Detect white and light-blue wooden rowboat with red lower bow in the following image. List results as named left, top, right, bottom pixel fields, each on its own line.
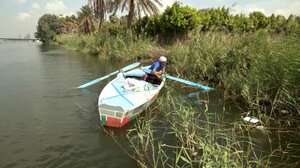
left=98, top=66, right=165, bottom=127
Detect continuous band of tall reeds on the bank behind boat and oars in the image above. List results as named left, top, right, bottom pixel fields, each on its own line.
left=57, top=31, right=300, bottom=117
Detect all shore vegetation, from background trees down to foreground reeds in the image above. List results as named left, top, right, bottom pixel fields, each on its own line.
left=36, top=2, right=300, bottom=167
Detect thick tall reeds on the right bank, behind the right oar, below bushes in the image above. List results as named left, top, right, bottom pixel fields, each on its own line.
left=168, top=31, right=300, bottom=116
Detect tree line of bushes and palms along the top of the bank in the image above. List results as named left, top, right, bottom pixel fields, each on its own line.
left=35, top=0, right=300, bottom=43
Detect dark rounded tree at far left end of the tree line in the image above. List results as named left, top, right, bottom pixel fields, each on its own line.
left=35, top=14, right=61, bottom=43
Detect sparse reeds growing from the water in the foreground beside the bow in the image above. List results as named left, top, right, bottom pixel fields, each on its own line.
left=127, top=88, right=300, bottom=168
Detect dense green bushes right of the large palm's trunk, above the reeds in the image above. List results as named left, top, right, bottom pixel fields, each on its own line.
left=135, top=2, right=300, bottom=38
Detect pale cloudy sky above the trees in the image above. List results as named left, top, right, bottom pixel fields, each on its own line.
left=0, top=0, right=300, bottom=38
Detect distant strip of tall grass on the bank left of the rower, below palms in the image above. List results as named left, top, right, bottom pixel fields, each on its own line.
left=58, top=33, right=164, bottom=61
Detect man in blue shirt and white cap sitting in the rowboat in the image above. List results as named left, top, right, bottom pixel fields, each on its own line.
left=146, top=56, right=167, bottom=85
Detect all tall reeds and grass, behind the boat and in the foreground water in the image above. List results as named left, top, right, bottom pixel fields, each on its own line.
left=57, top=28, right=300, bottom=167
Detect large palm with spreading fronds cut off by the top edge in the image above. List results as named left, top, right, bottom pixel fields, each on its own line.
left=107, top=0, right=162, bottom=29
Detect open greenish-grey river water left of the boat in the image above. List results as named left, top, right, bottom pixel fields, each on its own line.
left=0, top=42, right=137, bottom=168
